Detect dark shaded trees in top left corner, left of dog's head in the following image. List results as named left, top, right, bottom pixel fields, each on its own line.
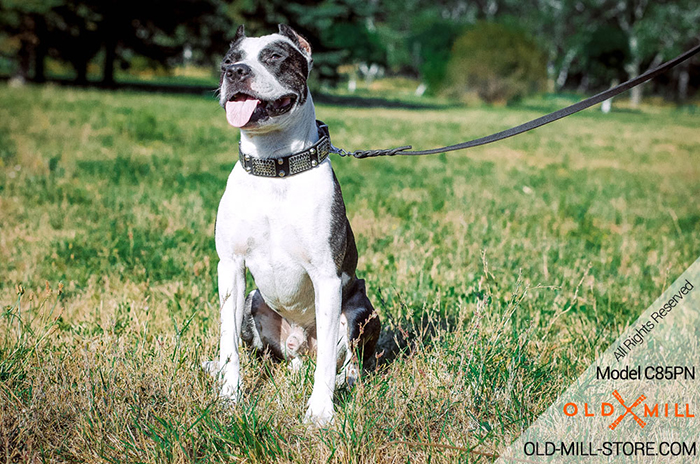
left=0, top=0, right=230, bottom=84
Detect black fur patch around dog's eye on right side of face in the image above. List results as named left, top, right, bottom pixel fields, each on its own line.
left=258, top=40, right=309, bottom=105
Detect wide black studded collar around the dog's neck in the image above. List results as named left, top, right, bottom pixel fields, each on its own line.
left=238, top=121, right=332, bottom=177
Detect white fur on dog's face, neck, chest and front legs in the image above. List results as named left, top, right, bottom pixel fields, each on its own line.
left=216, top=35, right=342, bottom=425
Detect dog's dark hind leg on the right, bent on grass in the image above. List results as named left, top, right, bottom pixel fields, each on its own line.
left=336, top=279, right=382, bottom=386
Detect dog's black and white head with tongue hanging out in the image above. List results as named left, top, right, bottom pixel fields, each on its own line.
left=219, top=24, right=313, bottom=130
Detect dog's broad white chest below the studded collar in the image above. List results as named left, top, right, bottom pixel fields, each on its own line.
left=216, top=162, right=334, bottom=316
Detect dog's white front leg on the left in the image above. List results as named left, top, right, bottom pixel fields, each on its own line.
left=218, top=258, right=245, bottom=401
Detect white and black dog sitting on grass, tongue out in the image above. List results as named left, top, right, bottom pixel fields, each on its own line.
left=215, top=25, right=381, bottom=426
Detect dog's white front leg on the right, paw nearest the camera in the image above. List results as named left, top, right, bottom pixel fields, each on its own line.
left=306, top=275, right=342, bottom=426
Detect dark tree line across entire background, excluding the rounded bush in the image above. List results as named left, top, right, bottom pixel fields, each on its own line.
left=0, top=0, right=700, bottom=102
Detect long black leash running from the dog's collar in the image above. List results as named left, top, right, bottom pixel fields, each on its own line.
left=333, top=45, right=700, bottom=159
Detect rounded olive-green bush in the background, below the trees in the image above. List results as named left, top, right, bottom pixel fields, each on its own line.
left=446, top=22, right=547, bottom=103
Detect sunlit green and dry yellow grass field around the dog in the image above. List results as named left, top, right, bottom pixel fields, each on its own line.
left=0, top=86, right=700, bottom=463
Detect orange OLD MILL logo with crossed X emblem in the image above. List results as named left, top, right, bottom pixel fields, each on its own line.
left=564, top=390, right=695, bottom=430
